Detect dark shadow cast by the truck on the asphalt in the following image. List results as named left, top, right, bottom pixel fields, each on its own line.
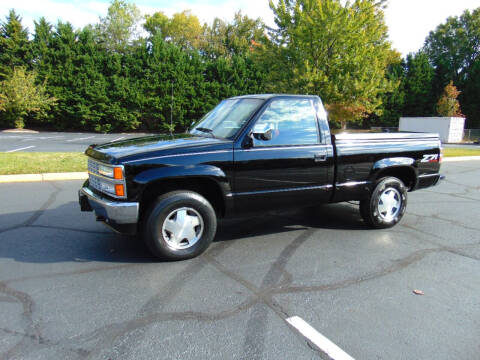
left=0, top=201, right=367, bottom=263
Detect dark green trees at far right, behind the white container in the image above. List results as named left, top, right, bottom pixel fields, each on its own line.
left=376, top=8, right=480, bottom=128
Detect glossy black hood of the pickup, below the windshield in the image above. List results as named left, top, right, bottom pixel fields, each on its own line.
left=85, top=134, right=232, bottom=164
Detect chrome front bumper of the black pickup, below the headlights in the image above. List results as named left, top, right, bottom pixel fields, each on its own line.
left=78, top=187, right=139, bottom=224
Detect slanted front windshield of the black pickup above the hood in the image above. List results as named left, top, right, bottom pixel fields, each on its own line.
left=190, top=99, right=263, bottom=139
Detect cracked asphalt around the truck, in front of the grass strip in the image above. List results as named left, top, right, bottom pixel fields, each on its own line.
left=0, top=161, right=480, bottom=360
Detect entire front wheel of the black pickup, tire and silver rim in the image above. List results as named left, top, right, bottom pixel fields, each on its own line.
left=141, top=191, right=217, bottom=260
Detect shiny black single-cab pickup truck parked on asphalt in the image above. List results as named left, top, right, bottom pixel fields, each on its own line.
left=79, top=95, right=441, bottom=260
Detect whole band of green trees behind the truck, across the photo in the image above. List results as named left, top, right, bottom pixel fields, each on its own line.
left=0, top=0, right=480, bottom=132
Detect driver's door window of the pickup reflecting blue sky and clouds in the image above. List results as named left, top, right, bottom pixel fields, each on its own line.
left=253, top=99, right=319, bottom=147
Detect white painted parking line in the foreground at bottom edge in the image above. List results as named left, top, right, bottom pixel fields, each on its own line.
left=286, top=316, right=354, bottom=360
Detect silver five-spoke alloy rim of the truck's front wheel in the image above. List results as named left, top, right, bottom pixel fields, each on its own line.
left=162, top=207, right=204, bottom=250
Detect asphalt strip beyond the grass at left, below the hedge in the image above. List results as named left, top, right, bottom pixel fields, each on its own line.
left=0, top=132, right=148, bottom=152
